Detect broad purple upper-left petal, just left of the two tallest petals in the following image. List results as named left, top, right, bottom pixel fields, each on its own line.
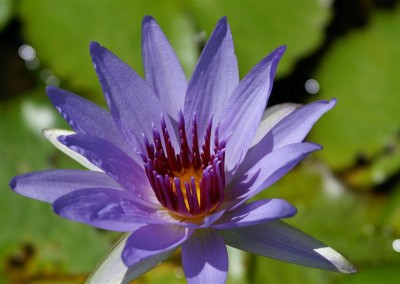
left=90, top=42, right=177, bottom=153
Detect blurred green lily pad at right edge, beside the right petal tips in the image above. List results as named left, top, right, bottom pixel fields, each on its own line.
left=310, top=9, right=400, bottom=171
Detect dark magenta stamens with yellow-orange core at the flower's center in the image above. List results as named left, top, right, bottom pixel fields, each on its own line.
left=142, top=112, right=226, bottom=222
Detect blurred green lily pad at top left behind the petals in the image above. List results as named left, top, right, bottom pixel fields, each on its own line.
left=19, top=0, right=198, bottom=94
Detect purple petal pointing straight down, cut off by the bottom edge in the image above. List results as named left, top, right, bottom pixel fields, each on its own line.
left=182, top=230, right=228, bottom=284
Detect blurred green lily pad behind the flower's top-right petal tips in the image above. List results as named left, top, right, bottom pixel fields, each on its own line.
left=191, top=0, right=330, bottom=76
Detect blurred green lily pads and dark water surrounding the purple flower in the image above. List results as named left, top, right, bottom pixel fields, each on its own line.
left=0, top=0, right=400, bottom=283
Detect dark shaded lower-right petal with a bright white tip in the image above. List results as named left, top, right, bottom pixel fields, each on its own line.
left=221, top=221, right=357, bottom=273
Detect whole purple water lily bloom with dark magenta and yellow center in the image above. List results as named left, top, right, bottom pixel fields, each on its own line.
left=10, top=16, right=356, bottom=283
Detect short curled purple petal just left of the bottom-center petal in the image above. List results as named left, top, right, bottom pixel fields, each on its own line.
left=122, top=225, right=192, bottom=266
